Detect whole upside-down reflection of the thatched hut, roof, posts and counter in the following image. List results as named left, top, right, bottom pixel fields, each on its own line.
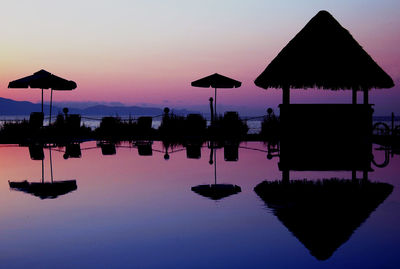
left=254, top=140, right=393, bottom=260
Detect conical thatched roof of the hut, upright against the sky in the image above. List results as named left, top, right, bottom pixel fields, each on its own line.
left=255, top=11, right=394, bottom=90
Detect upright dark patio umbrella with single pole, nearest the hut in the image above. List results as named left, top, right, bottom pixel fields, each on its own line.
left=191, top=73, right=242, bottom=119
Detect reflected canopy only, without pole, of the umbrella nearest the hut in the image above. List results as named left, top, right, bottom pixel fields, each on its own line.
left=192, top=184, right=242, bottom=200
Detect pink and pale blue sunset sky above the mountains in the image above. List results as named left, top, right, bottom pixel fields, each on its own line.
left=0, top=0, right=400, bottom=115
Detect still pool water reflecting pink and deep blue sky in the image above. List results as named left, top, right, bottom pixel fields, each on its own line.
left=0, top=142, right=400, bottom=268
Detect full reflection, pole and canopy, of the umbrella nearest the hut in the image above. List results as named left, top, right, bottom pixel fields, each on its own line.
left=192, top=140, right=242, bottom=200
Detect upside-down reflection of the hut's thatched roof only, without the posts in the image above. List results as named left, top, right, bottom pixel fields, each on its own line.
left=254, top=179, right=393, bottom=260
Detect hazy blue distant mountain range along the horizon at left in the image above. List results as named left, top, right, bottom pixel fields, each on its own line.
left=0, top=97, right=198, bottom=116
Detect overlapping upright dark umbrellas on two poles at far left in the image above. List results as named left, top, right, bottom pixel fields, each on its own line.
left=8, top=69, right=76, bottom=122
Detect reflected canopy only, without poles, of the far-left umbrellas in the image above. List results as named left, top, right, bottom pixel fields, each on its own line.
left=8, top=180, right=78, bottom=199
